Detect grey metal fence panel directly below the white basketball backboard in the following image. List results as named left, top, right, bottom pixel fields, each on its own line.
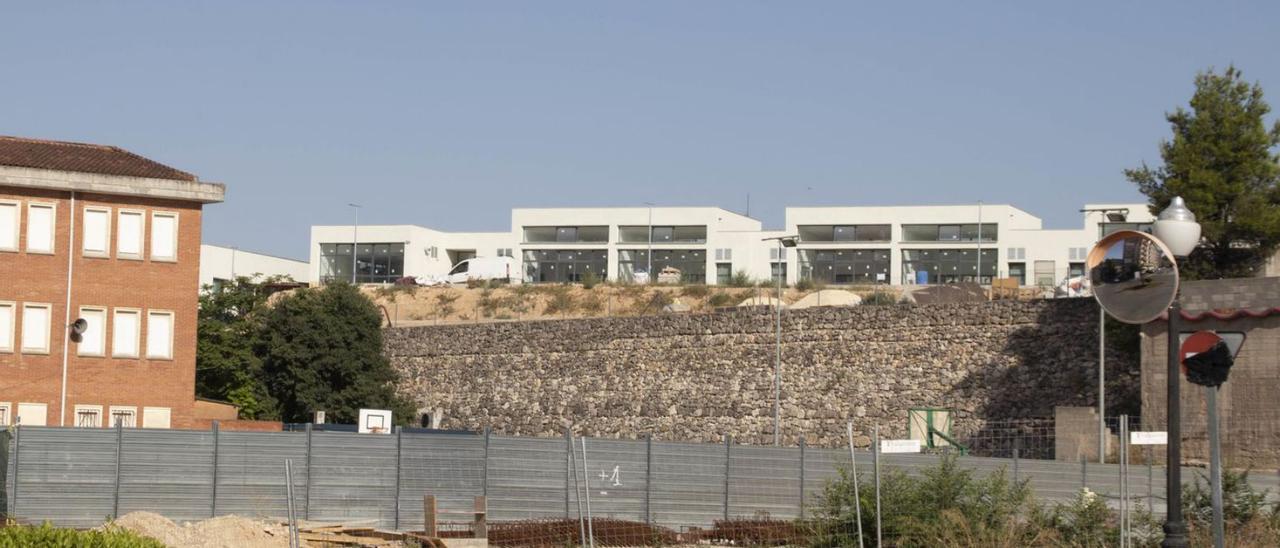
left=305, top=431, right=397, bottom=528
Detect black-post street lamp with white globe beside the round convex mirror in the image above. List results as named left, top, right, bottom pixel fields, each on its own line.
left=1152, top=196, right=1201, bottom=548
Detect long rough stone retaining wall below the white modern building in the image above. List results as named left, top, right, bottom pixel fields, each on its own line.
left=385, top=298, right=1137, bottom=446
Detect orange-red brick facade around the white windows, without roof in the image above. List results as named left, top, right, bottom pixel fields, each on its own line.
left=0, top=186, right=201, bottom=428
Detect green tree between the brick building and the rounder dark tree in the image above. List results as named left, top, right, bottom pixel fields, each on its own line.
left=196, top=277, right=279, bottom=419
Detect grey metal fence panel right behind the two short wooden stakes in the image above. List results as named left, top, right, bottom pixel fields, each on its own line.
left=399, top=434, right=485, bottom=530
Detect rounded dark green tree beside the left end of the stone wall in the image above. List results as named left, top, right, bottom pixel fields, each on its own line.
left=257, top=283, right=416, bottom=424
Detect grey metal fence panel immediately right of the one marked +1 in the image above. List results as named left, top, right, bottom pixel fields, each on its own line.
left=650, top=442, right=726, bottom=530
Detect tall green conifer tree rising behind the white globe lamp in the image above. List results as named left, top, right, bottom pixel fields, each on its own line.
left=1125, top=67, right=1280, bottom=279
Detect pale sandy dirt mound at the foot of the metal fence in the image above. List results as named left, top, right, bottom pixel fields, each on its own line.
left=109, top=512, right=289, bottom=548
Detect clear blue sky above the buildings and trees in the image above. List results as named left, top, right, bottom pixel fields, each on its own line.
left=0, top=1, right=1280, bottom=257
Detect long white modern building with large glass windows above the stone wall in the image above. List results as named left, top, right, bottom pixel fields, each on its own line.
left=307, top=204, right=1153, bottom=286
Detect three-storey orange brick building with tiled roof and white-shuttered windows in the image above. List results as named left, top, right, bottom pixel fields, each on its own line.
left=0, top=137, right=224, bottom=428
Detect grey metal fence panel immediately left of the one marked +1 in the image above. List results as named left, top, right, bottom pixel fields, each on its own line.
left=488, top=435, right=565, bottom=521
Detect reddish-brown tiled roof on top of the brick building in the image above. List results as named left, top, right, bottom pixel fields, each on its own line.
left=0, top=136, right=197, bottom=182
